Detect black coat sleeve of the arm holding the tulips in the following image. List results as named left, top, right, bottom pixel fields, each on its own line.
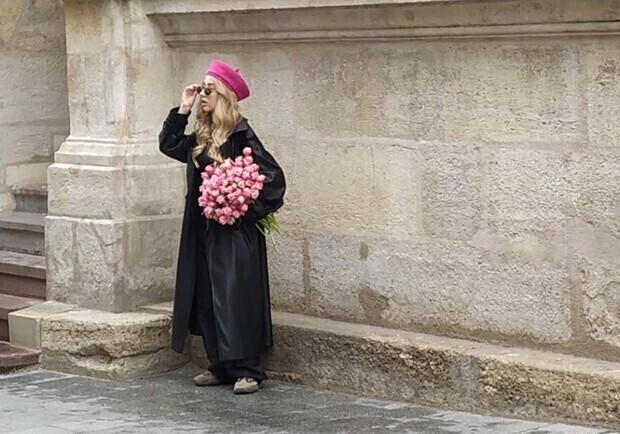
left=245, top=129, right=286, bottom=222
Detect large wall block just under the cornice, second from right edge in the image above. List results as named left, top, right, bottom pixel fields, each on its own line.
left=436, top=43, right=585, bottom=146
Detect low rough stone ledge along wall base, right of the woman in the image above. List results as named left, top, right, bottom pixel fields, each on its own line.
left=267, top=312, right=620, bottom=427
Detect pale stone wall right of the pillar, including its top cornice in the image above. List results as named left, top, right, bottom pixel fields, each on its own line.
left=154, top=0, right=620, bottom=359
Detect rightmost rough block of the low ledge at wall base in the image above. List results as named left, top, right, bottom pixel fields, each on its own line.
left=475, top=351, right=620, bottom=428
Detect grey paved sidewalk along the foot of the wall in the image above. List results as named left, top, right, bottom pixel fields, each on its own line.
left=0, top=371, right=613, bottom=434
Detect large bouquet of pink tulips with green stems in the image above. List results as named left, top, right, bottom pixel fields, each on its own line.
left=198, top=147, right=278, bottom=245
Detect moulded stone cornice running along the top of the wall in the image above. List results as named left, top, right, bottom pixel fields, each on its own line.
left=147, top=0, right=620, bottom=47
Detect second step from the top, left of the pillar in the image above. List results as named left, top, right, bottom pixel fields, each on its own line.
left=0, top=211, right=45, bottom=255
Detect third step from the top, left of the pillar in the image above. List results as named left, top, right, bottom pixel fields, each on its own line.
left=0, top=250, right=46, bottom=300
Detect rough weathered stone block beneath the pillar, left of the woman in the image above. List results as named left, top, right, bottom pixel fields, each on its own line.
left=41, top=307, right=189, bottom=379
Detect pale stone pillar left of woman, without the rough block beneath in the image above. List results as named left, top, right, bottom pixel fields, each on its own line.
left=46, top=0, right=184, bottom=312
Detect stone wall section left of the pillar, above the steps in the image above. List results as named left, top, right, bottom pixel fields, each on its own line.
left=0, top=0, right=69, bottom=211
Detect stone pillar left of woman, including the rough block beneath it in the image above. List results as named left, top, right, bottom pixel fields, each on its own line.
left=41, top=0, right=184, bottom=378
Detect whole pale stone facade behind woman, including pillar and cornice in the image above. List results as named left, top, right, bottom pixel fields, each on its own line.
left=48, top=0, right=620, bottom=360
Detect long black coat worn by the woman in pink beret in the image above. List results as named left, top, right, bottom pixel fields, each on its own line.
left=159, top=108, right=286, bottom=361
